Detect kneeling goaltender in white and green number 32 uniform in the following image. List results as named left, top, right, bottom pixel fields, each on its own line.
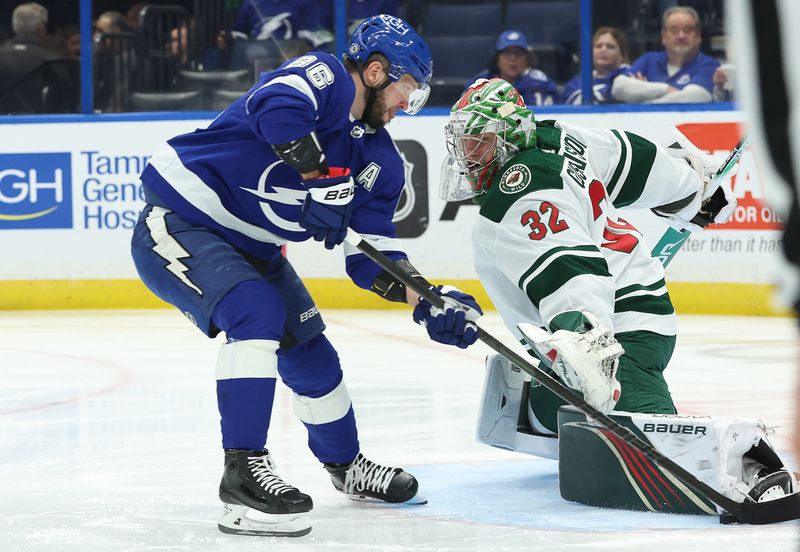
left=441, top=79, right=796, bottom=513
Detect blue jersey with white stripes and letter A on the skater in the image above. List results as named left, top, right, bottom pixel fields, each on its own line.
left=141, top=52, right=405, bottom=289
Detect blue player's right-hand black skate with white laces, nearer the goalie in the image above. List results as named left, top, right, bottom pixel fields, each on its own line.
left=325, top=452, right=428, bottom=504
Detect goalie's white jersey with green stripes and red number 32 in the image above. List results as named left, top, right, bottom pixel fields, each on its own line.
left=473, top=121, right=703, bottom=339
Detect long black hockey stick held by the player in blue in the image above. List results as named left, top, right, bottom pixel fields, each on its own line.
left=345, top=229, right=800, bottom=525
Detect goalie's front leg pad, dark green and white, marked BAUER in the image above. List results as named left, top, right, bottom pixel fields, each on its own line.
left=558, top=406, right=796, bottom=515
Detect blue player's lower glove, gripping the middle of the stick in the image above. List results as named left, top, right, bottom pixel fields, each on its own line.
left=413, top=286, right=483, bottom=349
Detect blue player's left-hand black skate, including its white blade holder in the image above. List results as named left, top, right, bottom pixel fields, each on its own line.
left=217, top=449, right=313, bottom=537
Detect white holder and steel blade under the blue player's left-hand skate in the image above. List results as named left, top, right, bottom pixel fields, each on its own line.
left=217, top=504, right=311, bottom=537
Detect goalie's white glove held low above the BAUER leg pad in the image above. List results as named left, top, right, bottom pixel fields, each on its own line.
left=517, top=312, right=625, bottom=414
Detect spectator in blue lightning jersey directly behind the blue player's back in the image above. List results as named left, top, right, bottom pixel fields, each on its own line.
left=233, top=0, right=333, bottom=50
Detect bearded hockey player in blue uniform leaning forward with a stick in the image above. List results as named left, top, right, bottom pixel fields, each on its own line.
left=132, top=15, right=481, bottom=536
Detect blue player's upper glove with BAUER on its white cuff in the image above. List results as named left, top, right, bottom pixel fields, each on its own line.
left=300, top=167, right=355, bottom=249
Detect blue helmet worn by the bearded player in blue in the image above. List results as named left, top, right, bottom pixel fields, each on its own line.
left=344, top=14, right=433, bottom=86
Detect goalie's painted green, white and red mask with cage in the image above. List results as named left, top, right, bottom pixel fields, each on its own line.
left=439, top=78, right=536, bottom=201
